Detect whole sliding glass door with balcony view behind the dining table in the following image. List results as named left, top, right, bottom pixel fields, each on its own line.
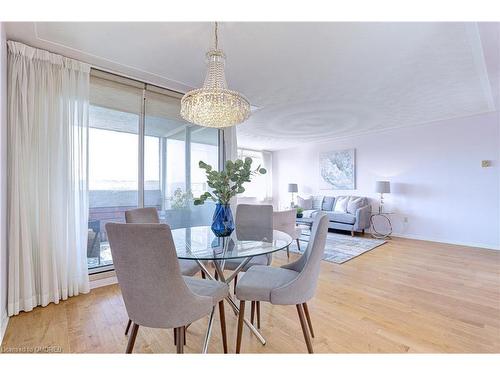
left=87, top=72, right=219, bottom=272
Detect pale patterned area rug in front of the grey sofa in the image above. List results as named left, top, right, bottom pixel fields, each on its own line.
left=290, top=231, right=386, bottom=264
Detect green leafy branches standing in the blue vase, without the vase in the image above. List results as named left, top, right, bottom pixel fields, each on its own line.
left=194, top=157, right=267, bottom=206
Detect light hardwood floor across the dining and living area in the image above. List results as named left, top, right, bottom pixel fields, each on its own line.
left=2, top=239, right=500, bottom=353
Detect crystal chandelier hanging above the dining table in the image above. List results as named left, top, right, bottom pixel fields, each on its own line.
left=181, top=22, right=250, bottom=128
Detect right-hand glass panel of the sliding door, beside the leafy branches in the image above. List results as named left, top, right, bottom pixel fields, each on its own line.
left=144, top=87, right=219, bottom=229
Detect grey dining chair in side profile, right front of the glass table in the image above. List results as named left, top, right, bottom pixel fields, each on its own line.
left=236, top=214, right=328, bottom=353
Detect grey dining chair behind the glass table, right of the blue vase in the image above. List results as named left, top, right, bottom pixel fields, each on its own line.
left=225, top=204, right=273, bottom=328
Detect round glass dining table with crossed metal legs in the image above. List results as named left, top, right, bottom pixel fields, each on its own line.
left=172, top=226, right=292, bottom=353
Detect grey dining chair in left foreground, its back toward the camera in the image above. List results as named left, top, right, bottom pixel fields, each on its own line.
left=106, top=223, right=229, bottom=353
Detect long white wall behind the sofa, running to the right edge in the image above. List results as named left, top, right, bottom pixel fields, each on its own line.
left=273, top=112, right=500, bottom=249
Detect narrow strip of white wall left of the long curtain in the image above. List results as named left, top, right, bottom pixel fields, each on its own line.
left=0, top=22, right=7, bottom=342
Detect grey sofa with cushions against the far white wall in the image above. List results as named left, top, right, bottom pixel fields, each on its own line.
left=304, top=196, right=371, bottom=236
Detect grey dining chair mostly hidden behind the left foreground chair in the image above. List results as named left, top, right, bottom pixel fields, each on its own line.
left=125, top=207, right=205, bottom=344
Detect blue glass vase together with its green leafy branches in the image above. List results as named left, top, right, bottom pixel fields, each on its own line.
left=194, top=158, right=267, bottom=237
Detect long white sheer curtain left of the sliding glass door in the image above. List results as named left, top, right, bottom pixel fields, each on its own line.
left=8, top=42, right=90, bottom=315
